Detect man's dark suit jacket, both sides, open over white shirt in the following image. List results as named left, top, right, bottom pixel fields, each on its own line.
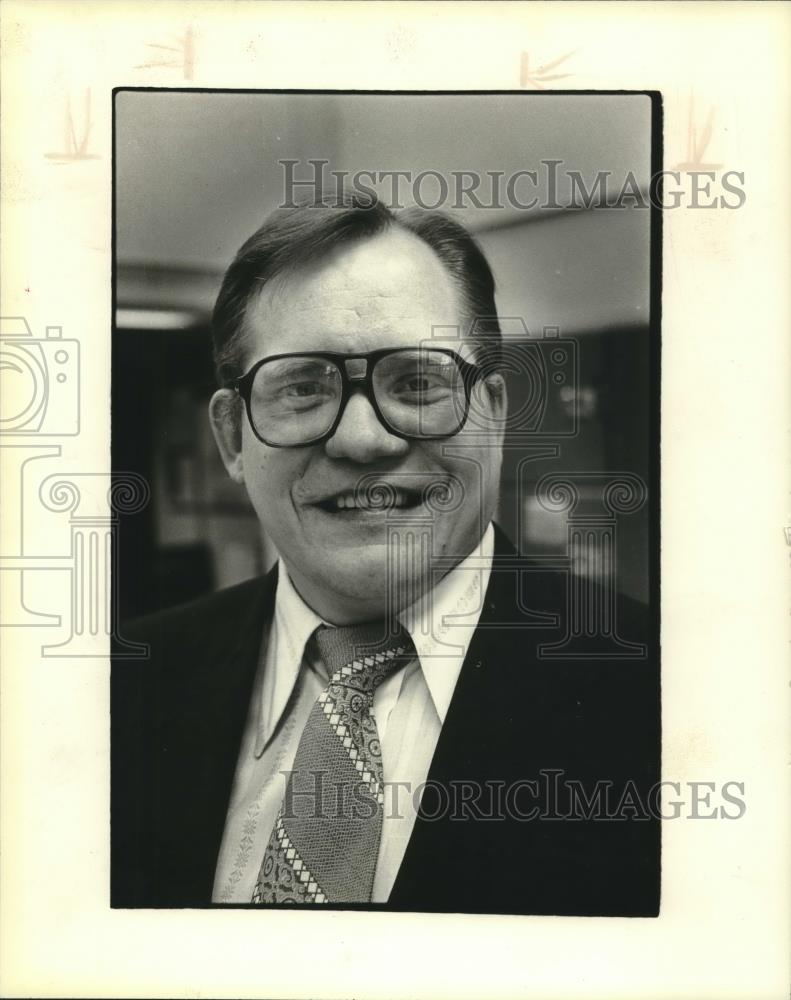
left=112, top=531, right=660, bottom=916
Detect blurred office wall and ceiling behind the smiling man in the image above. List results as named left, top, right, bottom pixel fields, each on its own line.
left=112, top=91, right=658, bottom=619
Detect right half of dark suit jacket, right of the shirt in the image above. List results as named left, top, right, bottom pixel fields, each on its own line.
left=389, top=535, right=660, bottom=916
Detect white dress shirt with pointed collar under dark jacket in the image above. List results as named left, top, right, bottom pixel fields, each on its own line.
left=212, top=524, right=494, bottom=903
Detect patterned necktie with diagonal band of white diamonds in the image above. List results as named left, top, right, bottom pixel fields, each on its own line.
left=252, top=622, right=417, bottom=903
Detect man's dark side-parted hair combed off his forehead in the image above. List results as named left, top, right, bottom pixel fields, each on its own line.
left=212, top=192, right=500, bottom=385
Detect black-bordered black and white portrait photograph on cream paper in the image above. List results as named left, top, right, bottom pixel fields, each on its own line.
left=111, top=89, right=661, bottom=917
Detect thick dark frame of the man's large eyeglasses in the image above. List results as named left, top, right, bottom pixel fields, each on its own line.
left=229, top=347, right=484, bottom=448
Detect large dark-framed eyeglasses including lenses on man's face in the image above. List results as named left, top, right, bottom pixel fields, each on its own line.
left=231, top=347, right=484, bottom=448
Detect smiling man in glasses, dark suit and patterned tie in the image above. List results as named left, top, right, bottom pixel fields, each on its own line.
left=112, top=189, right=659, bottom=915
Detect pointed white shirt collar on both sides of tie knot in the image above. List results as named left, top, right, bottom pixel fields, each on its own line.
left=256, top=524, right=494, bottom=752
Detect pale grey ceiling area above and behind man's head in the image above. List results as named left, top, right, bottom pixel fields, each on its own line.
left=115, top=91, right=651, bottom=331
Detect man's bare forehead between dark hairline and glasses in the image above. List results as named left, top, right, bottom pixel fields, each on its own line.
left=245, top=229, right=462, bottom=362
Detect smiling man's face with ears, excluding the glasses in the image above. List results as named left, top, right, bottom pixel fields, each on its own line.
left=212, top=229, right=505, bottom=624
